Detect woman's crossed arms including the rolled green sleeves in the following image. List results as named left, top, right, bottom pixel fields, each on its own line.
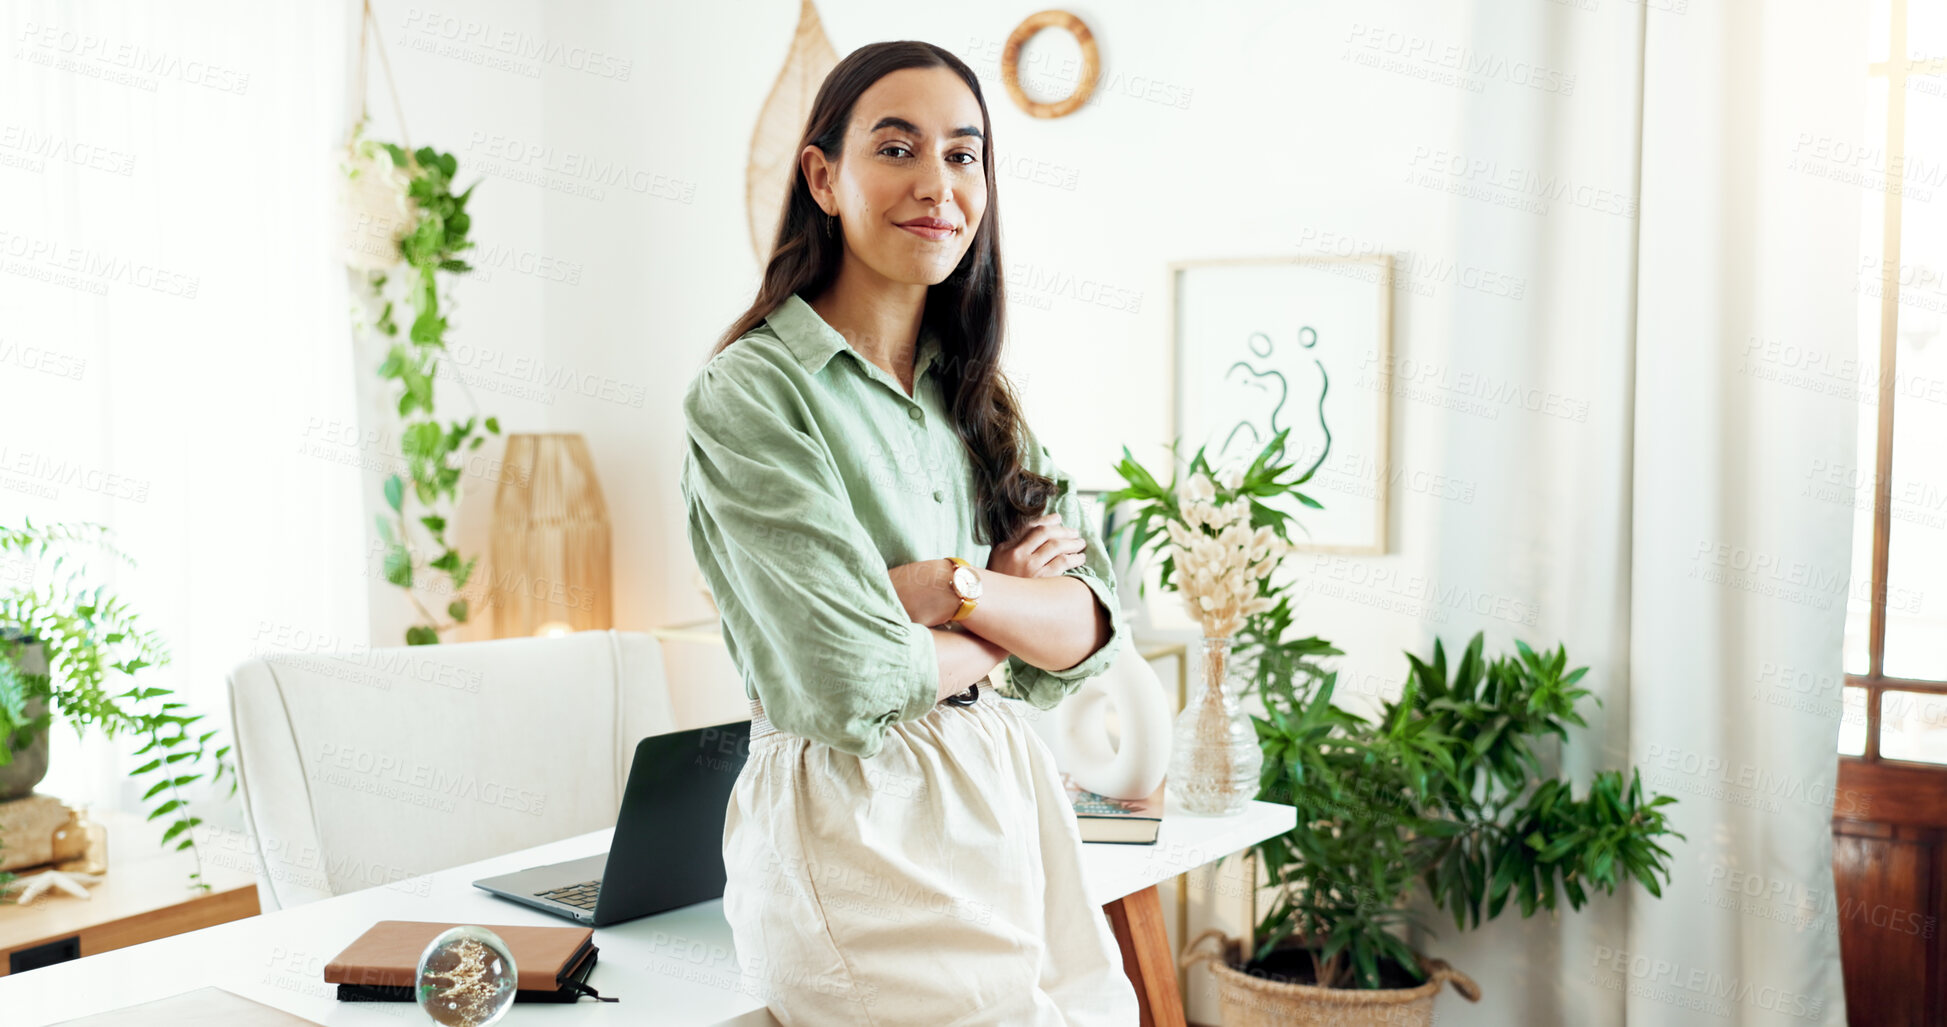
left=681, top=358, right=1123, bottom=758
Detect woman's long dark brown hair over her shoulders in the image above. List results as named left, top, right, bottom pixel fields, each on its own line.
left=711, top=39, right=1077, bottom=546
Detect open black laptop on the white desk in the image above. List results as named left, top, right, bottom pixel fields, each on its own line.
left=473, top=721, right=750, bottom=928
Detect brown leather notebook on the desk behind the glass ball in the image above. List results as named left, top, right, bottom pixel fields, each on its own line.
left=325, top=920, right=615, bottom=1002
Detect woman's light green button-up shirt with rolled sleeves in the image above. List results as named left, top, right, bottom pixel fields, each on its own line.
left=681, top=294, right=1127, bottom=758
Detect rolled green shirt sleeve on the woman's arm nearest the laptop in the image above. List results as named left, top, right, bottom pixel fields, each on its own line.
left=681, top=358, right=938, bottom=758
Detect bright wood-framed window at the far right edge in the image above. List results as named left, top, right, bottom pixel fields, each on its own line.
left=1837, top=0, right=1947, bottom=764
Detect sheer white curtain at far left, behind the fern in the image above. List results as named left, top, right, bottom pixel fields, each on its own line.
left=0, top=0, right=366, bottom=826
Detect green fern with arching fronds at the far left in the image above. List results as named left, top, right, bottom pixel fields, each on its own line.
left=0, top=518, right=238, bottom=891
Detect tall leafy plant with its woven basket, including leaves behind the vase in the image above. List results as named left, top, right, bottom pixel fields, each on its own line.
left=1106, top=433, right=1682, bottom=1027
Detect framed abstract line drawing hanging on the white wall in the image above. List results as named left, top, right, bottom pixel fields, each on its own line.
left=1170, top=255, right=1392, bottom=555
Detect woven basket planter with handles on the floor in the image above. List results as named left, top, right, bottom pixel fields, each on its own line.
left=1182, top=928, right=1480, bottom=1027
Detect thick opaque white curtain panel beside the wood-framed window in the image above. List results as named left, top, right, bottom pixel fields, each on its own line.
left=1628, top=0, right=1877, bottom=1023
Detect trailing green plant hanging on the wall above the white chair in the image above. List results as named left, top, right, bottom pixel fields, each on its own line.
left=349, top=125, right=500, bottom=645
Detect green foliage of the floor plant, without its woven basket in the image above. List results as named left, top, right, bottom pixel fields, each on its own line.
left=1250, top=622, right=1682, bottom=988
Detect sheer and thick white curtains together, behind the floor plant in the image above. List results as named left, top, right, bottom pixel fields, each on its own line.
left=1425, top=0, right=1871, bottom=1027
